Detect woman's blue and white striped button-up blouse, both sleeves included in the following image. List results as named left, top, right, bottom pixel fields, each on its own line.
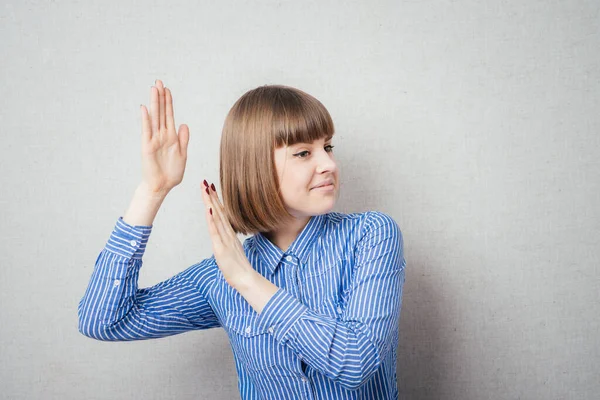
left=79, top=211, right=406, bottom=400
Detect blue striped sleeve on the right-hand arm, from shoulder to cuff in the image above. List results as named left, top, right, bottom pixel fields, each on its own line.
left=259, top=213, right=406, bottom=390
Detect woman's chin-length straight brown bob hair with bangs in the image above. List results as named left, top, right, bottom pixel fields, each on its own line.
left=219, top=85, right=334, bottom=235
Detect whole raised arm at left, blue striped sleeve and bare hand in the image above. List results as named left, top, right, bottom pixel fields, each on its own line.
left=78, top=80, right=212, bottom=340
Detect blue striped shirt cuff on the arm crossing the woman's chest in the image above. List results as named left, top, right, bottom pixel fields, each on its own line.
left=258, top=288, right=308, bottom=343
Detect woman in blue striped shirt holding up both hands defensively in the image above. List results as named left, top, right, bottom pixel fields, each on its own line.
left=79, top=81, right=406, bottom=400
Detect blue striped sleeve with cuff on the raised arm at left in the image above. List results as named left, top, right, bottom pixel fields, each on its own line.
left=78, top=218, right=220, bottom=341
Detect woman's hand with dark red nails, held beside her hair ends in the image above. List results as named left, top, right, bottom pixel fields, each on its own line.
left=202, top=180, right=256, bottom=288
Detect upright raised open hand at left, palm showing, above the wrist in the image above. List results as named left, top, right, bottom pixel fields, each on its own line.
left=140, top=80, right=190, bottom=195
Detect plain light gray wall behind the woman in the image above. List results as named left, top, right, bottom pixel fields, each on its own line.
left=0, top=0, right=600, bottom=400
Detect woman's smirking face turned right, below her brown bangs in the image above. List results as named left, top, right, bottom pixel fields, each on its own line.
left=274, top=139, right=339, bottom=218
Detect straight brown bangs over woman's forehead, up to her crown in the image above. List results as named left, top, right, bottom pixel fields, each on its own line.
left=272, top=86, right=335, bottom=148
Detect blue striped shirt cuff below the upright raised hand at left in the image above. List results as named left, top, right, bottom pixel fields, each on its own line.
left=105, top=217, right=152, bottom=259
